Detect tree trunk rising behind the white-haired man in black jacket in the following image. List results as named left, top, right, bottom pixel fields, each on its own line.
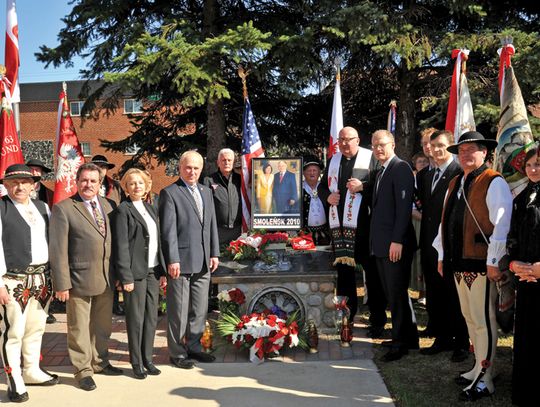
left=203, top=0, right=225, bottom=173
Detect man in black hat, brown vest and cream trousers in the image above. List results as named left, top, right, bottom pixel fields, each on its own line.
left=433, top=131, right=512, bottom=401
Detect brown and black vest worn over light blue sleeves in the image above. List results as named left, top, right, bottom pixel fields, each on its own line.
left=441, top=166, right=501, bottom=272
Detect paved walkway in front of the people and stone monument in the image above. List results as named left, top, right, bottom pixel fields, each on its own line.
left=0, top=314, right=393, bottom=407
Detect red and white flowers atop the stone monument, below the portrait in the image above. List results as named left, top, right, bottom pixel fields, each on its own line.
left=226, top=232, right=289, bottom=262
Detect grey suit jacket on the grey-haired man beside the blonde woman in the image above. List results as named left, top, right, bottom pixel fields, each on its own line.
left=159, top=179, right=219, bottom=274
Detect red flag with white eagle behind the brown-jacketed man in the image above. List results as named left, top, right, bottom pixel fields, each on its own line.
left=53, top=90, right=84, bottom=204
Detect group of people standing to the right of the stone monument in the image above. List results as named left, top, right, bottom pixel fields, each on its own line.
left=318, top=127, right=540, bottom=405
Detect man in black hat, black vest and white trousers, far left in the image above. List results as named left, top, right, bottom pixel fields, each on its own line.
left=0, top=164, right=58, bottom=403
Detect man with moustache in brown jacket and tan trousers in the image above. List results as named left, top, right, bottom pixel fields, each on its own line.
left=49, top=163, right=122, bottom=391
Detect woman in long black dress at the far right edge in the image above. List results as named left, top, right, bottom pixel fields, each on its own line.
left=501, top=148, right=540, bottom=406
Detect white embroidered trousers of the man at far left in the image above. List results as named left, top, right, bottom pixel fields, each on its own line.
left=0, top=273, right=52, bottom=394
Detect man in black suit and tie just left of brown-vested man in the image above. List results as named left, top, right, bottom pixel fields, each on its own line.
left=418, top=130, right=469, bottom=362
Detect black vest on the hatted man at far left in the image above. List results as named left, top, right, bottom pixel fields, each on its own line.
left=0, top=196, right=49, bottom=270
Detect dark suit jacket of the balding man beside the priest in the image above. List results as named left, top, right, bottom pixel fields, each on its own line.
left=370, top=156, right=417, bottom=257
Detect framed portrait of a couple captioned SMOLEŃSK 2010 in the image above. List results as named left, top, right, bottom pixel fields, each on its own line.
left=251, top=157, right=302, bottom=230
